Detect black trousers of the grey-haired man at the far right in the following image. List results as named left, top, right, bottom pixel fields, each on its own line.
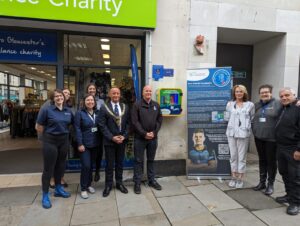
left=277, top=145, right=300, bottom=205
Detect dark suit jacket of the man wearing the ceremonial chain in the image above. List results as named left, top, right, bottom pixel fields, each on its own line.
left=99, top=102, right=130, bottom=145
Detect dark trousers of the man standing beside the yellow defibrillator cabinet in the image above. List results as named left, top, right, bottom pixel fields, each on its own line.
left=133, top=138, right=157, bottom=184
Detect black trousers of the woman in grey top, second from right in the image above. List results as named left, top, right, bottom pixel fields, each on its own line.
left=255, top=138, right=277, bottom=183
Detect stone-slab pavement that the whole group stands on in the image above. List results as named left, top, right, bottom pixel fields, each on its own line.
left=0, top=154, right=300, bottom=226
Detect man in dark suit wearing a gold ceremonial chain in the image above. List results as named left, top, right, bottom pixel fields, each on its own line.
left=99, top=88, right=129, bottom=197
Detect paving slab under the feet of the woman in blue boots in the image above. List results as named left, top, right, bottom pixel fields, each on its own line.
left=20, top=185, right=78, bottom=226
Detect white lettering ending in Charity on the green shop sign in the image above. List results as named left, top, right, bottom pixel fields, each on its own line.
left=6, top=0, right=123, bottom=17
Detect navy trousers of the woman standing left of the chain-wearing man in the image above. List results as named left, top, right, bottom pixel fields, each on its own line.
left=79, top=147, right=99, bottom=191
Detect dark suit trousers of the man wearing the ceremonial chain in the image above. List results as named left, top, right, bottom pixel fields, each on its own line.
left=104, top=144, right=125, bottom=187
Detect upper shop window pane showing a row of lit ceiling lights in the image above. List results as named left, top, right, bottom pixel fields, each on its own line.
left=64, top=35, right=141, bottom=67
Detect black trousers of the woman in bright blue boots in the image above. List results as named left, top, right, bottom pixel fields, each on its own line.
left=42, top=133, right=69, bottom=192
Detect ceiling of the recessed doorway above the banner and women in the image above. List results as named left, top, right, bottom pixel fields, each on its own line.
left=218, top=27, right=285, bottom=45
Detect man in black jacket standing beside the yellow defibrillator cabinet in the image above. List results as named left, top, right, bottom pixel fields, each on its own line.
left=131, top=85, right=162, bottom=194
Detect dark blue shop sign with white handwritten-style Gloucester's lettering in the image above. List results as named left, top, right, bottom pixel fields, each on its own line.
left=0, top=31, right=57, bottom=62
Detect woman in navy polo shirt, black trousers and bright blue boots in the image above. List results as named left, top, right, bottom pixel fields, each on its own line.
left=36, top=89, right=73, bottom=209
